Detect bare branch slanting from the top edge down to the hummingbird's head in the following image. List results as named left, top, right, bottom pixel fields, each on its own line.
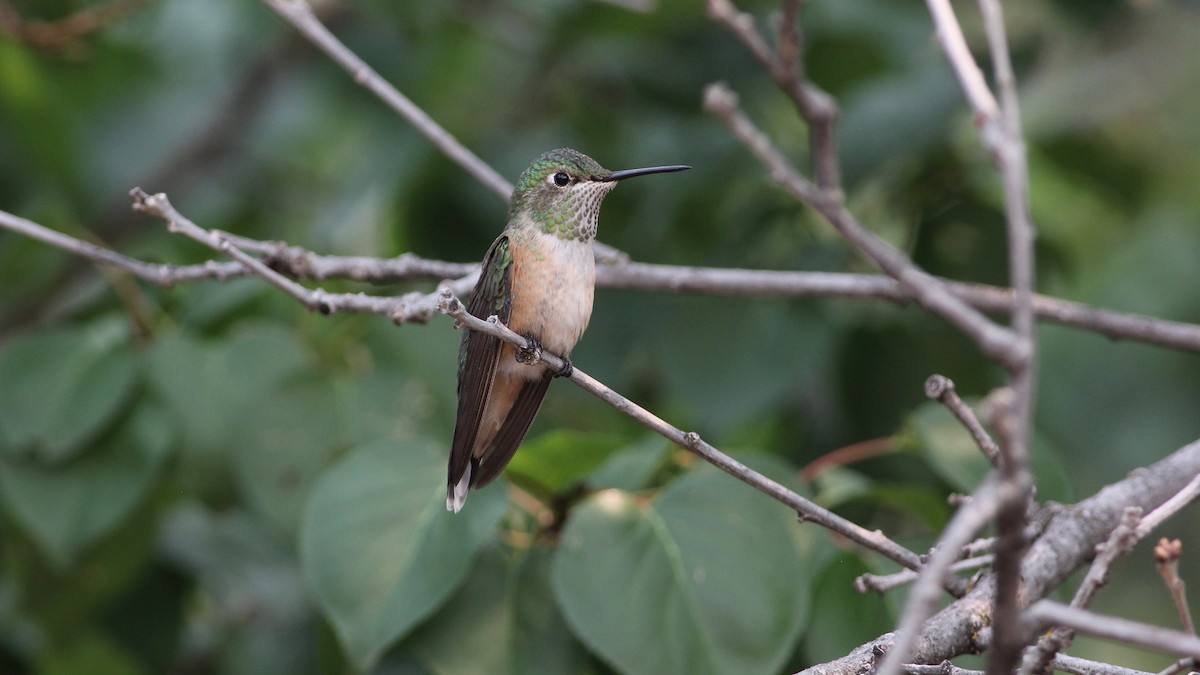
left=263, top=0, right=512, bottom=201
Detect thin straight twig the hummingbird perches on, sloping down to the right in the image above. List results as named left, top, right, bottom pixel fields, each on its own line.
left=439, top=289, right=920, bottom=569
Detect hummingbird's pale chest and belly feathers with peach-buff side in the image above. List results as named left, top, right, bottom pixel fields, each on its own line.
left=509, top=232, right=596, bottom=356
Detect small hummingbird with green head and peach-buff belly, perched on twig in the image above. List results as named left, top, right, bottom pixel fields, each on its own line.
left=446, top=148, right=691, bottom=513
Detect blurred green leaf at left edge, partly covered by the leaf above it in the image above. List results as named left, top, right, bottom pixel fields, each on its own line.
left=0, top=402, right=172, bottom=569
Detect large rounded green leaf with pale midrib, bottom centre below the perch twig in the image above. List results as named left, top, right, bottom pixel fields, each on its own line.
left=553, top=466, right=809, bottom=674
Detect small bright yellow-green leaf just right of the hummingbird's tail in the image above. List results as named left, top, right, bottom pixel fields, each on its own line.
left=505, top=429, right=620, bottom=494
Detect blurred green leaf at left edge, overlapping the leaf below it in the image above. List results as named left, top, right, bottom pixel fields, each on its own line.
left=0, top=321, right=137, bottom=462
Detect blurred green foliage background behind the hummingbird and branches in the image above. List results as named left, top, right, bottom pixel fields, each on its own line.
left=0, top=0, right=1200, bottom=675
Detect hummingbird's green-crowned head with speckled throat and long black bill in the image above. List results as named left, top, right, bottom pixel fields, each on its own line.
left=509, top=148, right=691, bottom=243
